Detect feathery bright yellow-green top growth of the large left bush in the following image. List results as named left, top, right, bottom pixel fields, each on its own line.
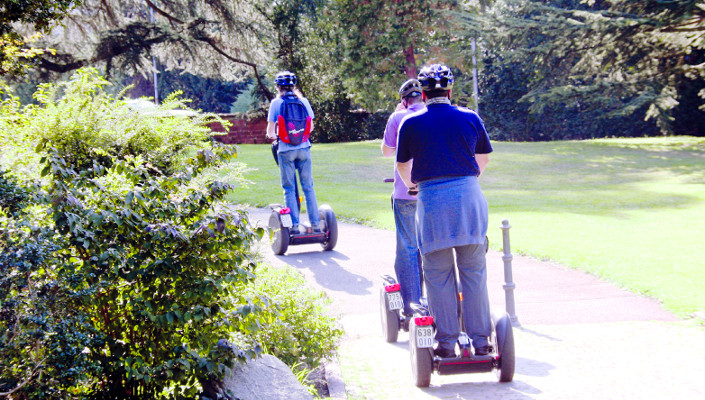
left=0, top=68, right=227, bottom=177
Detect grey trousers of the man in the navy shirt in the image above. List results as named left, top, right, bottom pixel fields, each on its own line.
left=423, top=244, right=492, bottom=350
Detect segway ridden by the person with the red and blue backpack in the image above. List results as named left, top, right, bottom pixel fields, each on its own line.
left=269, top=141, right=338, bottom=255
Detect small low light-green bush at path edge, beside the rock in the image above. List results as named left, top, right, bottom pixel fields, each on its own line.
left=241, top=265, right=343, bottom=369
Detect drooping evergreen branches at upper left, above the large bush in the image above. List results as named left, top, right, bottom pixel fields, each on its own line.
left=17, top=0, right=271, bottom=97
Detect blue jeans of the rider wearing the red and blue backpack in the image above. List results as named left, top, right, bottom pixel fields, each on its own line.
left=277, top=147, right=320, bottom=227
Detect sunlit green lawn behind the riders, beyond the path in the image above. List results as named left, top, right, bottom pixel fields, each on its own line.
left=227, top=137, right=705, bottom=316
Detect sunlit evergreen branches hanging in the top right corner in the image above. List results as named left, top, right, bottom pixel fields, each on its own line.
left=472, top=0, right=705, bottom=133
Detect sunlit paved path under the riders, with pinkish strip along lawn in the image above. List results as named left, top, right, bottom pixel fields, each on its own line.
left=243, top=210, right=705, bottom=400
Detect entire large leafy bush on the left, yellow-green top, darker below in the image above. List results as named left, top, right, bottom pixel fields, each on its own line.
left=0, top=71, right=264, bottom=399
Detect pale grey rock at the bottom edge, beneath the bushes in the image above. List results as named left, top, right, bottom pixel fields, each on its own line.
left=217, top=355, right=313, bottom=400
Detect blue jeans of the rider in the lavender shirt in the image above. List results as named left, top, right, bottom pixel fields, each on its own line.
left=392, top=198, right=423, bottom=315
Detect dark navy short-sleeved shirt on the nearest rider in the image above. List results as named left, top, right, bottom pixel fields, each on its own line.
left=397, top=104, right=492, bottom=183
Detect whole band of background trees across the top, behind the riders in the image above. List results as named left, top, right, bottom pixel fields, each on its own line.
left=6, top=0, right=705, bottom=141
